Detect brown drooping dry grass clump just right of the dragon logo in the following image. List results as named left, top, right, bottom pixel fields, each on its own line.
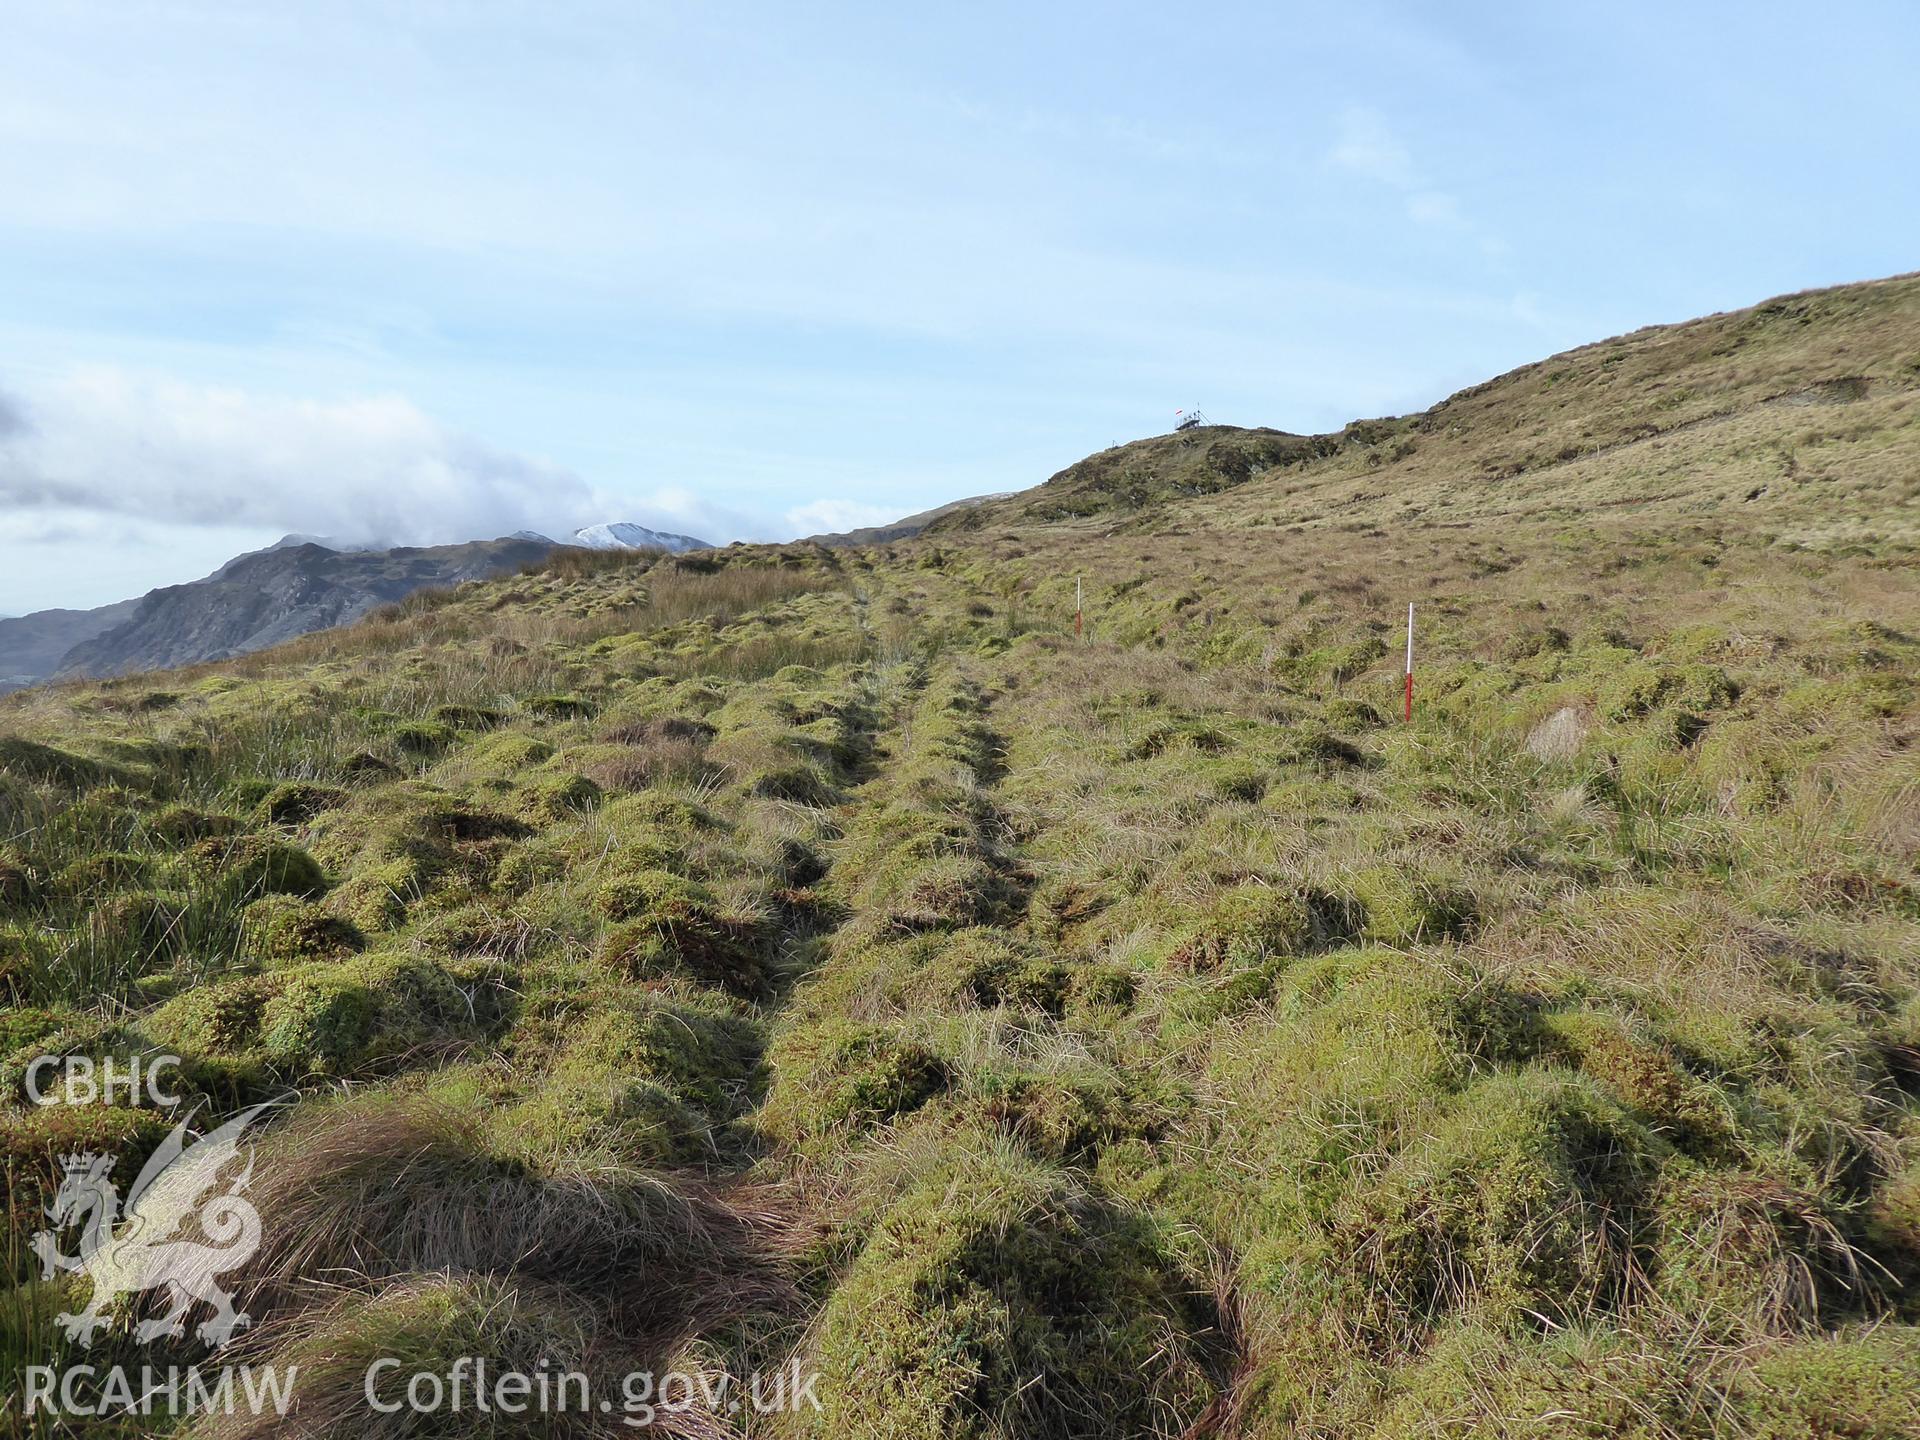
left=246, top=1096, right=793, bottom=1356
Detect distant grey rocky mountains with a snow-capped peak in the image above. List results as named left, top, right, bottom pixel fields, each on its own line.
left=0, top=520, right=710, bottom=691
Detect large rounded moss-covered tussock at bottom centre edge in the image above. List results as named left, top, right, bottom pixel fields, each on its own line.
left=806, top=1148, right=1217, bottom=1440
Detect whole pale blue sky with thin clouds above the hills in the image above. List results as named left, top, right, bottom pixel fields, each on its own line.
left=0, top=0, right=1920, bottom=612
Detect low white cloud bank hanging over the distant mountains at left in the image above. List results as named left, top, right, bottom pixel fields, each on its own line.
left=0, top=367, right=929, bottom=612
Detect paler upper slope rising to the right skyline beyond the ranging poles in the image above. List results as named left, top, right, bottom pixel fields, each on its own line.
left=935, top=276, right=1920, bottom=545
